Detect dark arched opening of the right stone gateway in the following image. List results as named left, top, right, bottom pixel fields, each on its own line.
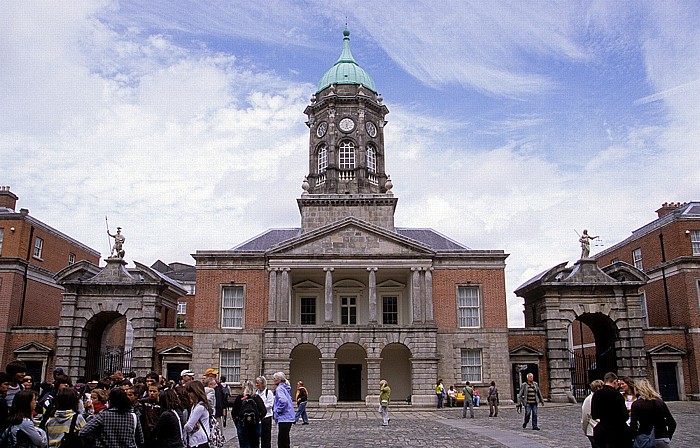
left=569, top=313, right=618, bottom=401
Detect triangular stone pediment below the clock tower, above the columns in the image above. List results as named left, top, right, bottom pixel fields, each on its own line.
left=268, top=217, right=434, bottom=256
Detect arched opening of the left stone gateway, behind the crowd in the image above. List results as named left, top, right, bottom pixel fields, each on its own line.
left=85, top=311, right=133, bottom=379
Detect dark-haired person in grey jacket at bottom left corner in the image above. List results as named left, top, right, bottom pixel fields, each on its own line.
left=7, top=390, right=47, bottom=448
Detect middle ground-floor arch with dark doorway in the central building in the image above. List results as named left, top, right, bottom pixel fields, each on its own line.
left=335, top=343, right=367, bottom=401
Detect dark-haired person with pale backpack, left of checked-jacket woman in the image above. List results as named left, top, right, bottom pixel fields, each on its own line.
left=45, top=387, right=85, bottom=448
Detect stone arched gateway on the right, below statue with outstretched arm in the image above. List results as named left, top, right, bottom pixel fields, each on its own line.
left=515, top=258, right=648, bottom=402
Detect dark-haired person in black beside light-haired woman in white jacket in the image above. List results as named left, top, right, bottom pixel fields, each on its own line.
left=231, top=380, right=267, bottom=448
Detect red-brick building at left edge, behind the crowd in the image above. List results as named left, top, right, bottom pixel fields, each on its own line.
left=0, top=187, right=100, bottom=379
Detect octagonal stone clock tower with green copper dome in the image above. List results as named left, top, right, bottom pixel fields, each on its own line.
left=297, top=28, right=397, bottom=232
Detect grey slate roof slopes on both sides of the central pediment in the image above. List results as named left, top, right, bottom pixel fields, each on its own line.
left=231, top=227, right=469, bottom=252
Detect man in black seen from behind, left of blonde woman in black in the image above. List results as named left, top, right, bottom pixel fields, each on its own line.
left=591, top=372, right=632, bottom=448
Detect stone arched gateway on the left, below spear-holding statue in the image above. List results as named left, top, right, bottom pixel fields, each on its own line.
left=56, top=257, right=187, bottom=378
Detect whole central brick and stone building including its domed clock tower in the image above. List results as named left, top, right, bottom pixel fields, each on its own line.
left=183, top=30, right=510, bottom=406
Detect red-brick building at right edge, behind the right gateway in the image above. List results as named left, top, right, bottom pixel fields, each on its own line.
left=595, top=202, right=700, bottom=399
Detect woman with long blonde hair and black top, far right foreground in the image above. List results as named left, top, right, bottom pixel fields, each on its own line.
left=630, top=380, right=676, bottom=448
